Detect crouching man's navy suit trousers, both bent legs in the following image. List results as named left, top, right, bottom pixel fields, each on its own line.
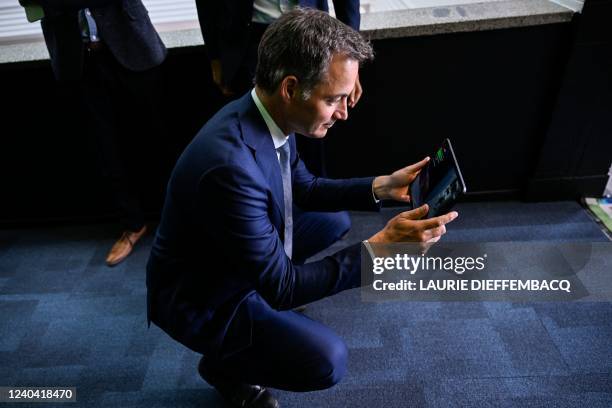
left=203, top=209, right=350, bottom=391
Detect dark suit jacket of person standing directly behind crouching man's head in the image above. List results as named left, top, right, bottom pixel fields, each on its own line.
left=196, top=0, right=361, bottom=86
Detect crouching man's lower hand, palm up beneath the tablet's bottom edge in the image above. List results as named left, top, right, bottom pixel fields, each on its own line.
left=368, top=204, right=459, bottom=244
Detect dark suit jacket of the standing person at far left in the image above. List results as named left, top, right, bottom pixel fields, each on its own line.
left=39, top=0, right=167, bottom=80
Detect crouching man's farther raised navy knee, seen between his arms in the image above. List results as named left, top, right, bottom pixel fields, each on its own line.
left=292, top=206, right=351, bottom=264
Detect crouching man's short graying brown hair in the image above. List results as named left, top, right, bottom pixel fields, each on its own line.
left=255, top=7, right=374, bottom=99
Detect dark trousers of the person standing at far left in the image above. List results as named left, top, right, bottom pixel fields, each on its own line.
left=81, top=44, right=164, bottom=231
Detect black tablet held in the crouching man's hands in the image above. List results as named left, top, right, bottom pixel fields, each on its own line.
left=410, top=139, right=467, bottom=218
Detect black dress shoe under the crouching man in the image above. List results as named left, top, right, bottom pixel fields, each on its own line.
left=198, top=358, right=280, bottom=408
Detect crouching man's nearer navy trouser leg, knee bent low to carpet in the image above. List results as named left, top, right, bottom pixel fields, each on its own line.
left=204, top=293, right=348, bottom=391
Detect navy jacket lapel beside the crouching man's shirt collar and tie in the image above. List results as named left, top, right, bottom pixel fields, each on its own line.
left=240, top=91, right=285, bottom=223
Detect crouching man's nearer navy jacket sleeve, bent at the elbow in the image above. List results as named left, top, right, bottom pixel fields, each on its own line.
left=197, top=165, right=361, bottom=309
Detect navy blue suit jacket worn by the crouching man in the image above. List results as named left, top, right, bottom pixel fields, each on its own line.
left=147, top=93, right=378, bottom=356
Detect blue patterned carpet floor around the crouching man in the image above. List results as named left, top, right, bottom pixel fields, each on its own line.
left=0, top=202, right=612, bottom=408
